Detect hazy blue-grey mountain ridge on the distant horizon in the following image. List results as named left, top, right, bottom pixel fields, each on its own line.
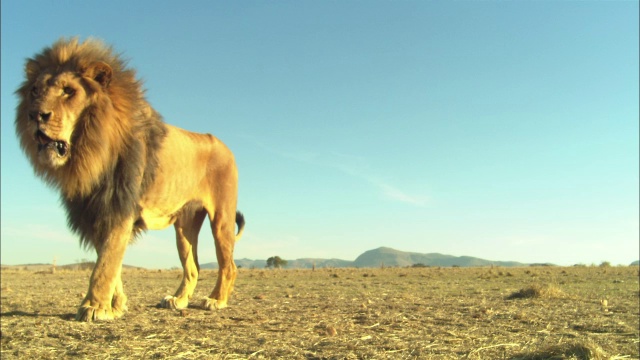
left=200, top=247, right=527, bottom=269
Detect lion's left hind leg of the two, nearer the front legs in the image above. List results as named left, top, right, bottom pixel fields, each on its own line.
left=160, top=210, right=207, bottom=309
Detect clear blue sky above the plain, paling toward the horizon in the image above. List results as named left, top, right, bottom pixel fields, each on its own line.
left=1, top=1, right=640, bottom=268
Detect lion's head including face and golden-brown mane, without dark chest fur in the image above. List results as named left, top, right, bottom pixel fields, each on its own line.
left=15, top=39, right=150, bottom=197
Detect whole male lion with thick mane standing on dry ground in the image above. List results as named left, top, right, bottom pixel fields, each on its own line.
left=15, top=38, right=245, bottom=321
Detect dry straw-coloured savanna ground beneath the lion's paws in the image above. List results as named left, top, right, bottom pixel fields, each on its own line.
left=0, top=266, right=640, bottom=359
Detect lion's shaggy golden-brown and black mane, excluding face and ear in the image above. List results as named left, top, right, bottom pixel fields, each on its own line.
left=16, top=38, right=167, bottom=249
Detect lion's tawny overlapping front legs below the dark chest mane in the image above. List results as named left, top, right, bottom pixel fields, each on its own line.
left=76, top=221, right=133, bottom=321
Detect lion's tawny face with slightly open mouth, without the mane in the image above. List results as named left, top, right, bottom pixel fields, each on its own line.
left=21, top=72, right=89, bottom=168
